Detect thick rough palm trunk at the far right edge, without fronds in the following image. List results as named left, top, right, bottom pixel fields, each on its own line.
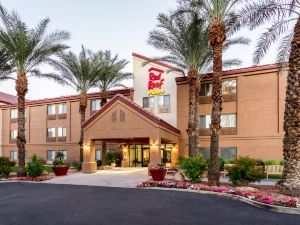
left=281, top=17, right=300, bottom=197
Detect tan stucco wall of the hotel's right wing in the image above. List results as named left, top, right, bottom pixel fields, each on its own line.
left=177, top=70, right=287, bottom=160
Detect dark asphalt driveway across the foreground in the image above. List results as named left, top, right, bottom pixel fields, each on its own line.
left=0, top=183, right=300, bottom=225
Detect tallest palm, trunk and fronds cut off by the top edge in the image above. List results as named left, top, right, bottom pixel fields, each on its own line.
left=179, top=0, right=243, bottom=186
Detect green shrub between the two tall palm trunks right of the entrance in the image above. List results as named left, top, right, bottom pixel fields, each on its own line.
left=180, top=156, right=207, bottom=183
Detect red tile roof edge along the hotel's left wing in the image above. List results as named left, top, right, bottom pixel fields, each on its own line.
left=3, top=88, right=133, bottom=108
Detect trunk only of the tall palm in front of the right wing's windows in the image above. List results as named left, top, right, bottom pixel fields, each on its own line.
left=208, top=20, right=226, bottom=186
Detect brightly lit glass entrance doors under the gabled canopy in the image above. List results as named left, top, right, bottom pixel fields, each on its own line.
left=129, top=144, right=150, bottom=167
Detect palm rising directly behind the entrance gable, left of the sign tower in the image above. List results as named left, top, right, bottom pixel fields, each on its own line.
left=95, top=51, right=133, bottom=165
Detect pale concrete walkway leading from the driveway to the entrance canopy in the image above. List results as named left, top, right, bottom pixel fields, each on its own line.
left=43, top=167, right=150, bottom=188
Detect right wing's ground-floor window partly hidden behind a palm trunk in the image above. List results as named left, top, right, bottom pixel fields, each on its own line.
left=198, top=147, right=237, bottom=161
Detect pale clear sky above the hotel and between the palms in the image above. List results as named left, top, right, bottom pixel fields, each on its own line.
left=0, top=0, right=275, bottom=99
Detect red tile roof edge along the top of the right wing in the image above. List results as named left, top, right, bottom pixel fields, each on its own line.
left=176, top=63, right=279, bottom=82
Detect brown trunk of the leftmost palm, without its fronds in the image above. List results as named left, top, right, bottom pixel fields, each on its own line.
left=16, top=73, right=28, bottom=176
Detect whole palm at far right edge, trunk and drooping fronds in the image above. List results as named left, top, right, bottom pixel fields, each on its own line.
left=240, top=0, right=300, bottom=197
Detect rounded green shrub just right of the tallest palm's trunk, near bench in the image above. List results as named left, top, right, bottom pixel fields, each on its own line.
left=227, top=157, right=265, bottom=186
